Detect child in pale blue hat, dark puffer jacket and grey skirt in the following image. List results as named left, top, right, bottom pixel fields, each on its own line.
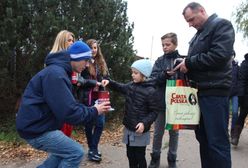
left=102, top=59, right=159, bottom=168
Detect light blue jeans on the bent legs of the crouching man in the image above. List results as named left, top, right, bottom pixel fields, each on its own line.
left=26, top=130, right=84, bottom=168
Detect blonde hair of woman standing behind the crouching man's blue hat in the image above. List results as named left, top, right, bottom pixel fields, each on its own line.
left=50, top=30, right=75, bottom=53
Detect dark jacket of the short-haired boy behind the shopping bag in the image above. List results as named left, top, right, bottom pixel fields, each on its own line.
left=151, top=50, right=182, bottom=112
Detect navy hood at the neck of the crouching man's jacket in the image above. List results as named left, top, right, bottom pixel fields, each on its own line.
left=45, top=50, right=72, bottom=74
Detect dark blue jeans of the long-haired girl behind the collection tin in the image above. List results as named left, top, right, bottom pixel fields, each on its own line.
left=85, top=115, right=105, bottom=152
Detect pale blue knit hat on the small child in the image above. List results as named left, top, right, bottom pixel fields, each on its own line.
left=131, top=59, right=152, bottom=77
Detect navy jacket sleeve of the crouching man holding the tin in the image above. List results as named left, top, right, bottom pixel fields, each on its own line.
left=42, top=70, right=98, bottom=125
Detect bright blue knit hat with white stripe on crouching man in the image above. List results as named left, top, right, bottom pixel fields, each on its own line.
left=68, top=41, right=92, bottom=61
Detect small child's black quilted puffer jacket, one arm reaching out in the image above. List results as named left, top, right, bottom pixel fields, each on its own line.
left=109, top=79, right=161, bottom=132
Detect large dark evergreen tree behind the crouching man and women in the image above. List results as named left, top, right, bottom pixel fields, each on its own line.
left=0, top=0, right=134, bottom=118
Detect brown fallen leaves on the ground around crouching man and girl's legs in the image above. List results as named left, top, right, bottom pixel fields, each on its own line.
left=0, top=120, right=123, bottom=164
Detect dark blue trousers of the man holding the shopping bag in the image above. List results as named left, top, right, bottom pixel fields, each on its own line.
left=195, top=96, right=231, bottom=168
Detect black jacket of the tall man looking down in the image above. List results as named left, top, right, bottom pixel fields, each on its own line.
left=185, top=14, right=235, bottom=96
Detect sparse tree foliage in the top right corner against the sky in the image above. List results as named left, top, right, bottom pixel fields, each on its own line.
left=234, top=0, right=248, bottom=38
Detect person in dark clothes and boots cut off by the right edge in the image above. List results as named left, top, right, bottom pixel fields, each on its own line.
left=231, top=53, right=248, bottom=146
